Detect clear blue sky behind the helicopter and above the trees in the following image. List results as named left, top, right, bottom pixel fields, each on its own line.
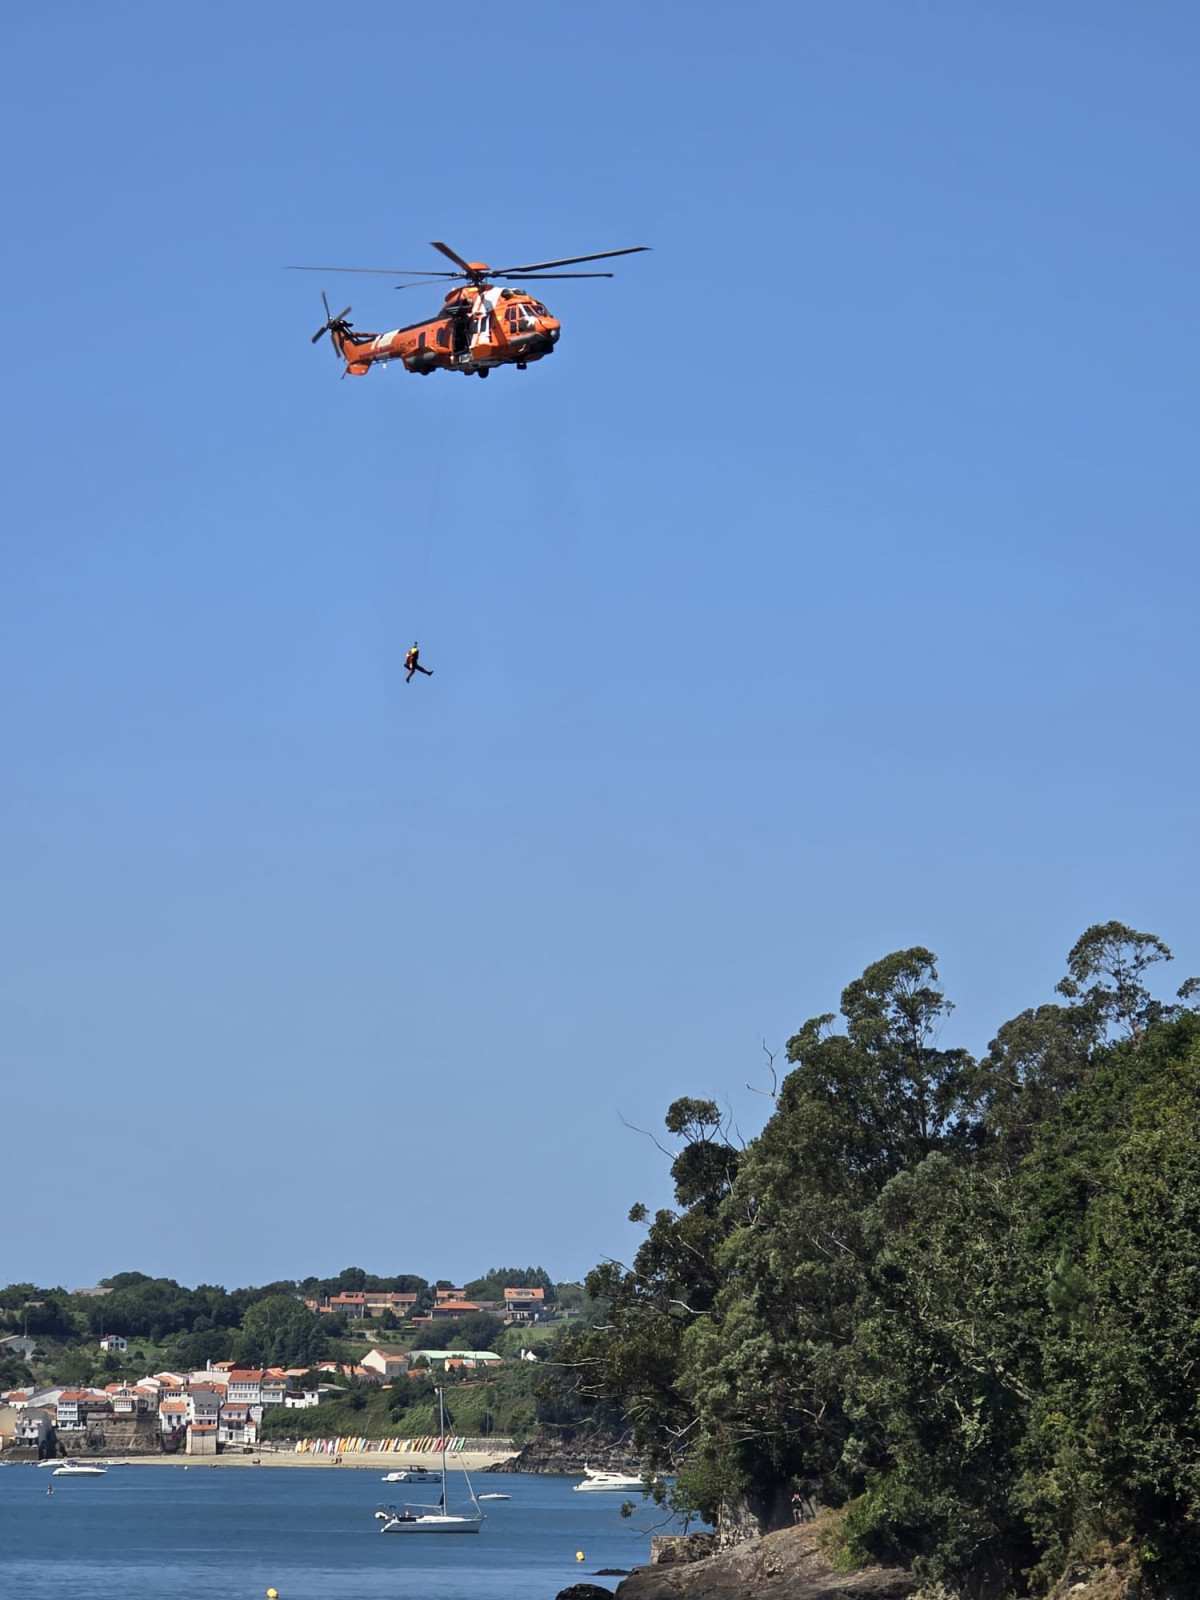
left=0, top=0, right=1200, bottom=1286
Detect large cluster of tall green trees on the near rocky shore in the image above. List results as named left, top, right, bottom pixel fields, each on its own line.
left=560, top=923, right=1200, bottom=1595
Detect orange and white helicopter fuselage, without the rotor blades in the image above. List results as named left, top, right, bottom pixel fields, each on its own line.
left=333, top=283, right=560, bottom=378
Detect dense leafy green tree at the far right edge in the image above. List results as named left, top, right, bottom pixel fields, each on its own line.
left=1021, top=1011, right=1200, bottom=1592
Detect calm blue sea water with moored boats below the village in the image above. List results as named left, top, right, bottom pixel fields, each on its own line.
left=0, top=1462, right=678, bottom=1600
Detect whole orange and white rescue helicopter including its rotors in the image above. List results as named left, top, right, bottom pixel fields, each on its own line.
left=288, top=240, right=650, bottom=378
